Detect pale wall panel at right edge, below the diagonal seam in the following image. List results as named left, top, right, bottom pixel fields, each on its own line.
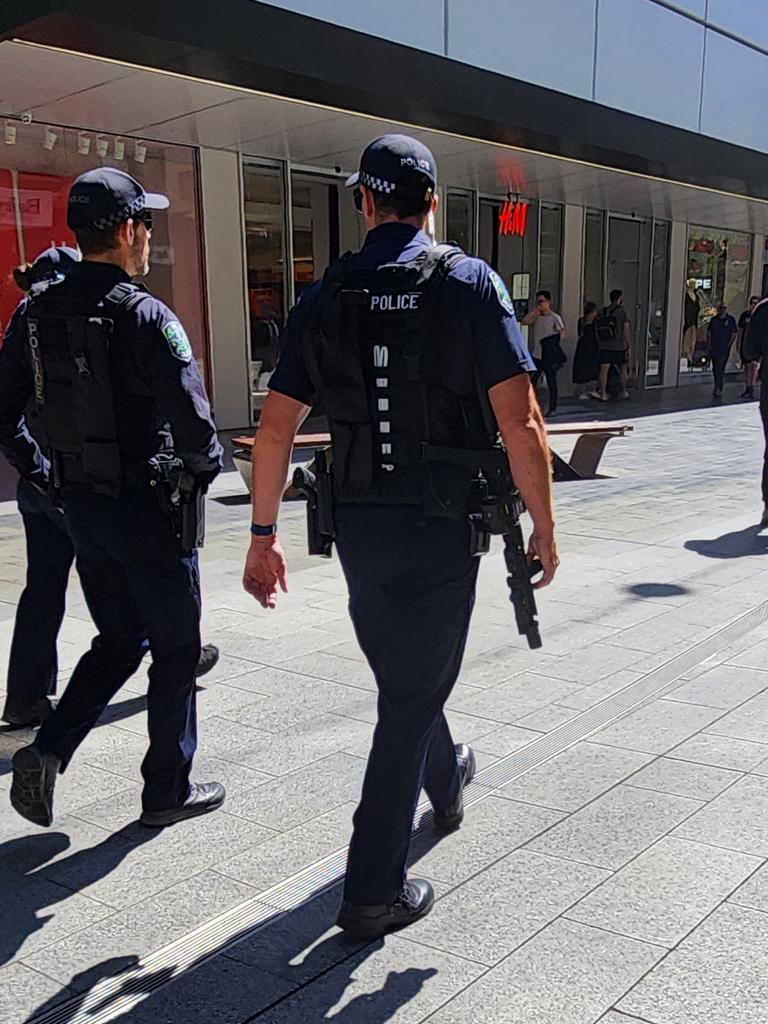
left=701, top=29, right=768, bottom=153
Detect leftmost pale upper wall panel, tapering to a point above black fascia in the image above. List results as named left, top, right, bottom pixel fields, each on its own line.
left=256, top=0, right=444, bottom=53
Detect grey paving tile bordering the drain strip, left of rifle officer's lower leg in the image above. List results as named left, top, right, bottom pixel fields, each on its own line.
left=216, top=803, right=355, bottom=891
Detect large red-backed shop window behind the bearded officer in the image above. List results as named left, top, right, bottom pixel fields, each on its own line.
left=0, top=121, right=208, bottom=374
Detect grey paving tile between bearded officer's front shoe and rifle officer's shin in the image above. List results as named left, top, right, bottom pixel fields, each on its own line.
left=222, top=754, right=366, bottom=831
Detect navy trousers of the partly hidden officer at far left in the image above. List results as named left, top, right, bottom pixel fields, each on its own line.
left=6, top=480, right=75, bottom=707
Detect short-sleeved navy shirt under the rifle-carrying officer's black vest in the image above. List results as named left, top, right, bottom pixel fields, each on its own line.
left=269, top=221, right=536, bottom=406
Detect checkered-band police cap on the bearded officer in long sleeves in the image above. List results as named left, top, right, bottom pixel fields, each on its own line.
left=67, top=167, right=170, bottom=231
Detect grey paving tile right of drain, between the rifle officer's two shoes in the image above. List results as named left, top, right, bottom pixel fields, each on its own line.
left=411, top=786, right=562, bottom=885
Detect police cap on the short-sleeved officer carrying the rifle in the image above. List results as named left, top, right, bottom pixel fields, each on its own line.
left=346, top=135, right=437, bottom=200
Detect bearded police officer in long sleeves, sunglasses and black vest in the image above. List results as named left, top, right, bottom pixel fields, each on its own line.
left=0, top=168, right=224, bottom=826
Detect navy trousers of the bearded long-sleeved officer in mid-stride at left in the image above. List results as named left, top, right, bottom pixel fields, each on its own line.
left=38, top=488, right=201, bottom=810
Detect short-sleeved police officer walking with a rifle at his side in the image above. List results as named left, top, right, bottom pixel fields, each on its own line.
left=244, top=135, right=557, bottom=938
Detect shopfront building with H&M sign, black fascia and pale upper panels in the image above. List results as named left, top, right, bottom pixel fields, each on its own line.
left=0, top=0, right=768, bottom=428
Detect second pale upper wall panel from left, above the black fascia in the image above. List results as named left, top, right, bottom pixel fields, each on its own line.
left=447, top=0, right=595, bottom=99
